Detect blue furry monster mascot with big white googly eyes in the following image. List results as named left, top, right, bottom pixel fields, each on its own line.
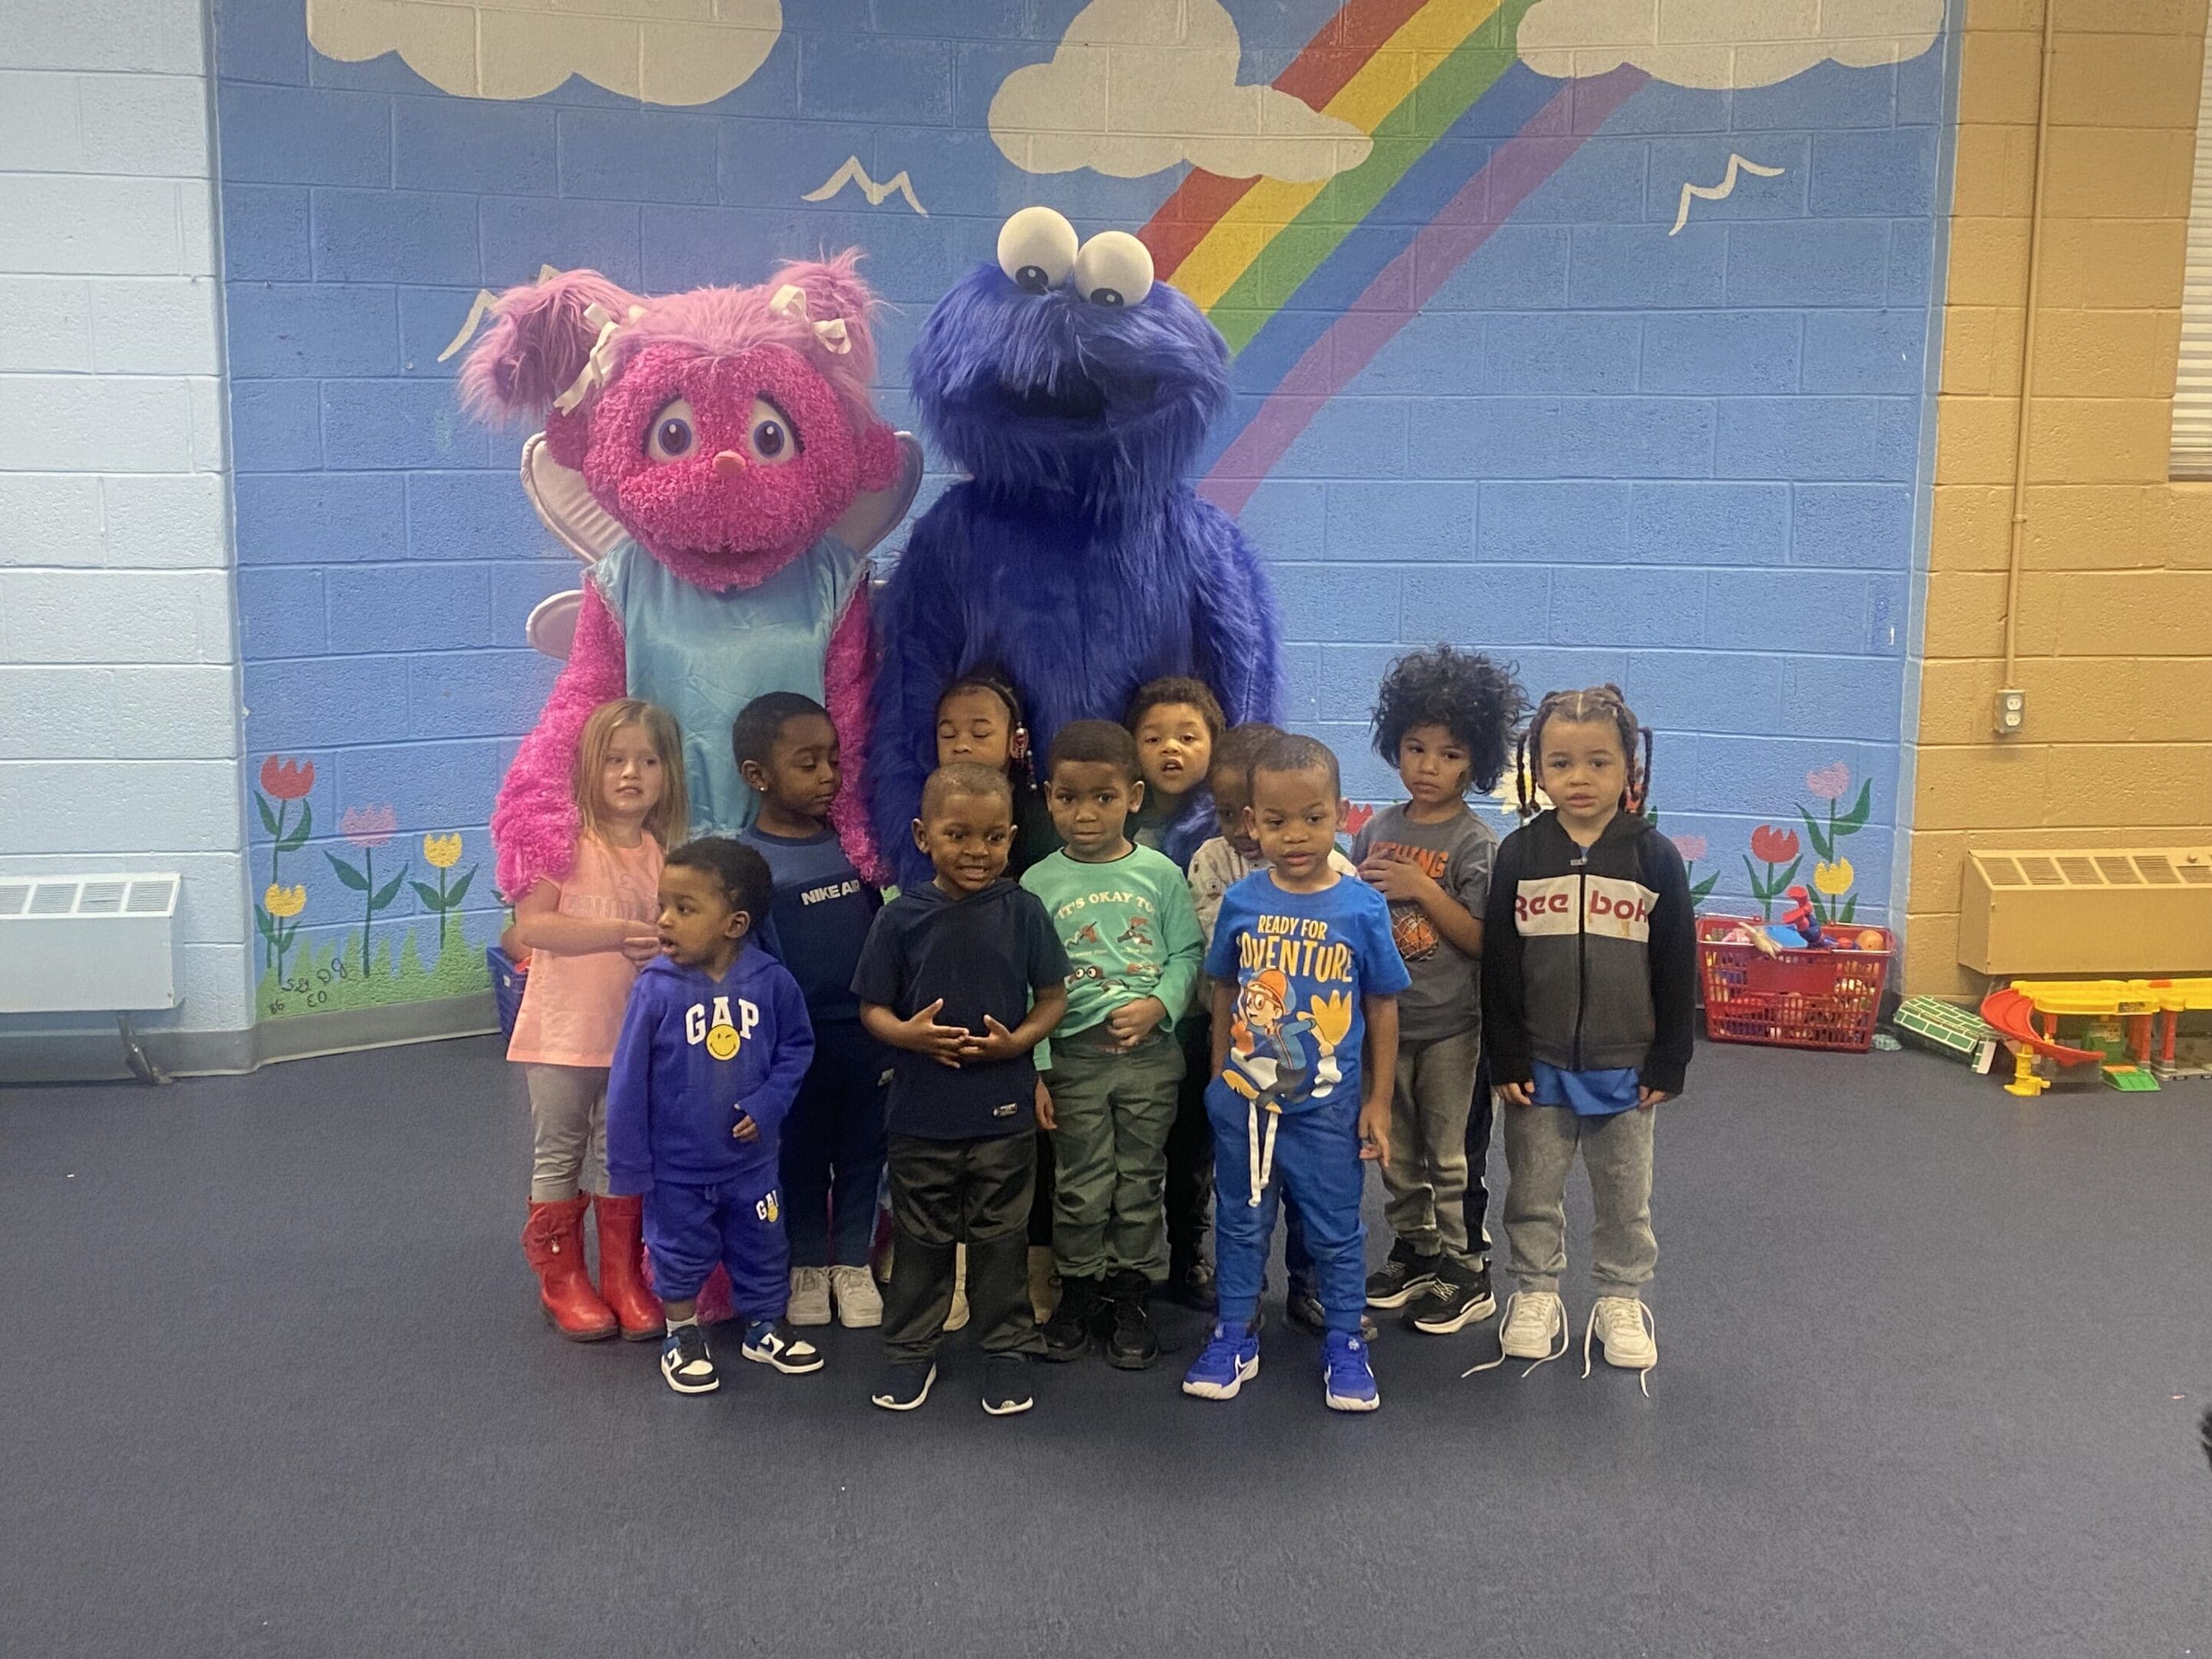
left=869, top=208, right=1281, bottom=882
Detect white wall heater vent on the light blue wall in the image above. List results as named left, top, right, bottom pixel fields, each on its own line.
left=0, top=874, right=179, bottom=1013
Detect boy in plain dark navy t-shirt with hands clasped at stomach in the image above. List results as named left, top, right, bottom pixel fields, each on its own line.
left=852, top=761, right=1068, bottom=1418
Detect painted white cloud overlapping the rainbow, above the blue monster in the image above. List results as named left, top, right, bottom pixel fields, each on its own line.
left=991, top=0, right=1373, bottom=181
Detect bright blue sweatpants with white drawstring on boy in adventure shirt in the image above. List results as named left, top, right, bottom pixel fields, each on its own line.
left=1206, top=1092, right=1367, bottom=1334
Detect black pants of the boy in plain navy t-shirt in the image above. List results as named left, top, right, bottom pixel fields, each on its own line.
left=882, top=1131, right=1038, bottom=1365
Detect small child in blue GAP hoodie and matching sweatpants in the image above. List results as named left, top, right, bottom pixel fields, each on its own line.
left=606, top=836, right=823, bottom=1393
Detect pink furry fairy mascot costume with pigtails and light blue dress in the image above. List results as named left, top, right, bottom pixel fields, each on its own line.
left=460, top=252, right=918, bottom=900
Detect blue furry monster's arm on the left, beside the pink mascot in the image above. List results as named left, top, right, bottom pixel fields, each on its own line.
left=867, top=499, right=973, bottom=887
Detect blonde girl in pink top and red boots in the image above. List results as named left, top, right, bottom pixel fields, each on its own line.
left=507, top=699, right=688, bottom=1343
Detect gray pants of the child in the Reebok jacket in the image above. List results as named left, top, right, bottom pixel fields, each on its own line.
left=1500, top=1101, right=1659, bottom=1296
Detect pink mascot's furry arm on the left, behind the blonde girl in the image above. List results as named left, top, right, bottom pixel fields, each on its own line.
left=491, top=575, right=628, bottom=905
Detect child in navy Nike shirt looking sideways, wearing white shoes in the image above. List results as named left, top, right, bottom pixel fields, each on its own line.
left=730, top=692, right=892, bottom=1327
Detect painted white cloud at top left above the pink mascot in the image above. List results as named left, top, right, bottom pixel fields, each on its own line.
left=307, top=0, right=783, bottom=104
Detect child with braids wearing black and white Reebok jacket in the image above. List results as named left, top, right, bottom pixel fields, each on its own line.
left=1475, top=686, right=1697, bottom=1376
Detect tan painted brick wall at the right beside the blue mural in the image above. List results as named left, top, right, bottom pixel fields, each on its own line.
left=1905, top=0, right=2212, bottom=995
